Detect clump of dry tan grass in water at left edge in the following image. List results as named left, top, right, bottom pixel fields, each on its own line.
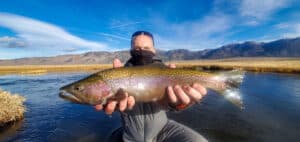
left=0, top=89, right=25, bottom=126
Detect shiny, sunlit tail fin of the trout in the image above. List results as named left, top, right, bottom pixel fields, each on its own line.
left=219, top=70, right=245, bottom=109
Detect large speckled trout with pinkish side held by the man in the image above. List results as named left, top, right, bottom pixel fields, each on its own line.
left=59, top=64, right=244, bottom=108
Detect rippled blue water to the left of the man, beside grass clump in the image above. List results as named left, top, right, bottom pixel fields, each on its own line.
left=0, top=73, right=120, bottom=142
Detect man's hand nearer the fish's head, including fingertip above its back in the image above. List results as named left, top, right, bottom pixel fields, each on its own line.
left=94, top=58, right=135, bottom=115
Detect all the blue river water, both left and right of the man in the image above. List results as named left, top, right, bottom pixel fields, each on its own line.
left=0, top=73, right=300, bottom=142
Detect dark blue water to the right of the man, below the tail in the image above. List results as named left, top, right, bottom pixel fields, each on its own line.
left=170, top=73, right=300, bottom=141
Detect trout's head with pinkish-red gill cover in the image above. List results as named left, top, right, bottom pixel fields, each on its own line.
left=59, top=77, right=112, bottom=105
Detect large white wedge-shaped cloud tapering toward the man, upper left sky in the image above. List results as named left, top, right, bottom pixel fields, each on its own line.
left=0, top=13, right=107, bottom=51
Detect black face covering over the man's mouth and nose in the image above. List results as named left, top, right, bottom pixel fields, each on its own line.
left=130, top=50, right=155, bottom=65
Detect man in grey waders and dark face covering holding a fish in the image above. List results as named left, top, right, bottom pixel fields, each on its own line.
left=95, top=31, right=207, bottom=142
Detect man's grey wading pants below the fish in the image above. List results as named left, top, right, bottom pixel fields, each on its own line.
left=109, top=103, right=207, bottom=142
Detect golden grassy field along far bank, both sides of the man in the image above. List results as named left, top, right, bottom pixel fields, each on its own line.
left=0, top=58, right=300, bottom=74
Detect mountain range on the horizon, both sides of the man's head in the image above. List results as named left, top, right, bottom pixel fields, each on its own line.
left=0, top=37, right=300, bottom=65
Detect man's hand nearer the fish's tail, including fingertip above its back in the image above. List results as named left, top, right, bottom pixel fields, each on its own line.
left=167, top=64, right=207, bottom=110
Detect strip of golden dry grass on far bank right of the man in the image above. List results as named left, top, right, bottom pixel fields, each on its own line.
left=169, top=58, right=300, bottom=73
